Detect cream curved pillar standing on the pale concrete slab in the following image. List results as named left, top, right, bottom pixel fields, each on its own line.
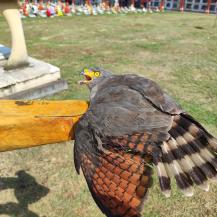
left=0, top=0, right=28, bottom=70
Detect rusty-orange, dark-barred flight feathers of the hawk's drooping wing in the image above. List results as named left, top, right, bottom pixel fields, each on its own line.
left=81, top=144, right=151, bottom=217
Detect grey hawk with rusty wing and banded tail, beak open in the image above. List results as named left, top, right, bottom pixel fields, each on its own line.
left=74, top=68, right=217, bottom=217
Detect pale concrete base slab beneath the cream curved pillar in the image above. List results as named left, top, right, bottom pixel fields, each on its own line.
left=0, top=45, right=68, bottom=99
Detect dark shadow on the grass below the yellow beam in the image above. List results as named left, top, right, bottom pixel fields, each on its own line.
left=0, top=170, right=49, bottom=217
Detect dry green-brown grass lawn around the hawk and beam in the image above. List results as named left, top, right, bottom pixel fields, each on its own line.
left=0, top=13, right=217, bottom=217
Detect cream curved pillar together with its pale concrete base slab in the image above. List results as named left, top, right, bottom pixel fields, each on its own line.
left=0, top=0, right=67, bottom=99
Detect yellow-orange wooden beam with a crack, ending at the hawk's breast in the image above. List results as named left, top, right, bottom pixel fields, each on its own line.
left=0, top=100, right=88, bottom=152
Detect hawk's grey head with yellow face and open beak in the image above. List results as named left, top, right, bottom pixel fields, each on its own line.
left=79, top=67, right=112, bottom=87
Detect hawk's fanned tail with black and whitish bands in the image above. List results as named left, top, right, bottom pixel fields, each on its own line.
left=157, top=114, right=217, bottom=196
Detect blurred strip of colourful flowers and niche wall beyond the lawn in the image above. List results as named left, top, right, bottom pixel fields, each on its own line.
left=19, top=0, right=217, bottom=18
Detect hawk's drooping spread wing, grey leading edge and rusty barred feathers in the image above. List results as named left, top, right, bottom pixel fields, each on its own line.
left=74, top=117, right=152, bottom=217
